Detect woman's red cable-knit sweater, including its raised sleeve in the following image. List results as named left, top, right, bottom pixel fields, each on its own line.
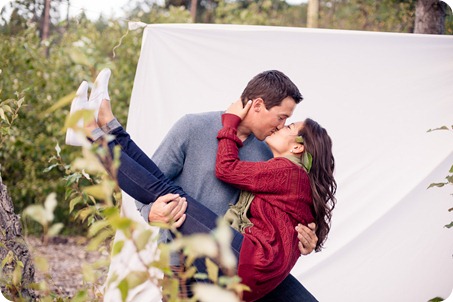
left=216, top=114, right=314, bottom=301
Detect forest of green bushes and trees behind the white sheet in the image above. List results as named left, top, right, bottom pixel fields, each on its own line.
left=0, top=0, right=453, bottom=300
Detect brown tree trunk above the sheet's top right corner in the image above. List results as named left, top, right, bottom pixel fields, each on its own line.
left=414, top=0, right=447, bottom=35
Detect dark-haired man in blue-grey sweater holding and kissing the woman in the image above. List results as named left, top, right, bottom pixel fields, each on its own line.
left=136, top=70, right=317, bottom=302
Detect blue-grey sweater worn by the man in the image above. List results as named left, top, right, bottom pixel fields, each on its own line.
left=136, top=111, right=272, bottom=221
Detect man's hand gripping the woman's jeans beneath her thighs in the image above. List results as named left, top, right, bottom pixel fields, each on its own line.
left=148, top=194, right=187, bottom=228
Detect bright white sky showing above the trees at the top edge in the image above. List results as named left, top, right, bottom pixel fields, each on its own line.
left=0, top=0, right=307, bottom=20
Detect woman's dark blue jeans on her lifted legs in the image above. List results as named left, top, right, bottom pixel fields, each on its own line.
left=105, top=126, right=243, bottom=259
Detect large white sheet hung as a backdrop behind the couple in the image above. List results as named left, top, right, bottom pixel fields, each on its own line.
left=106, top=24, right=453, bottom=301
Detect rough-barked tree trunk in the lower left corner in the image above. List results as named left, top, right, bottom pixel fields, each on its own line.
left=0, top=176, right=36, bottom=301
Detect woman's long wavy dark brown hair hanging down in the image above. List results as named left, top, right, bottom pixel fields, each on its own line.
left=299, top=118, right=337, bottom=252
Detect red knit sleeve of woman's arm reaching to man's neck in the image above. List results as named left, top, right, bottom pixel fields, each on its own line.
left=216, top=114, right=292, bottom=194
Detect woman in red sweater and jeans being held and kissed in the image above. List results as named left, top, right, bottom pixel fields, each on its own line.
left=67, top=72, right=336, bottom=301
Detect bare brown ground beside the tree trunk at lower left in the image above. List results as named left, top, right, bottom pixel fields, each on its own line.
left=27, top=237, right=108, bottom=297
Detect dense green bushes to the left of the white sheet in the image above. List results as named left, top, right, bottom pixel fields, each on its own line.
left=0, top=13, right=141, bottom=233
